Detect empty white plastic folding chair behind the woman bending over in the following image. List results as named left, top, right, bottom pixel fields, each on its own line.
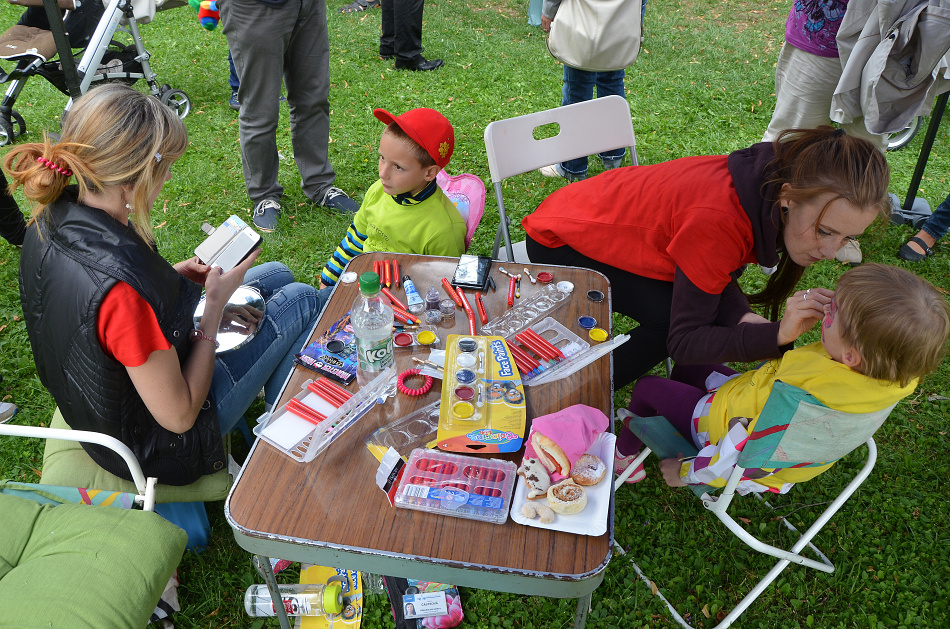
left=485, top=95, right=637, bottom=262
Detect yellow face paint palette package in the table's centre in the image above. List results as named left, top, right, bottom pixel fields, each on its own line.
left=438, top=334, right=527, bottom=454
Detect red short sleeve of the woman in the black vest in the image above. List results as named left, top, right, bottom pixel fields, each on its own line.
left=96, top=282, right=172, bottom=367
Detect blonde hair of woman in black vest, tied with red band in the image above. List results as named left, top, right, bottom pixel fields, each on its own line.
left=3, top=83, right=188, bottom=244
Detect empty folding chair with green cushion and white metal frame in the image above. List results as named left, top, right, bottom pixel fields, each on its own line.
left=0, top=414, right=188, bottom=629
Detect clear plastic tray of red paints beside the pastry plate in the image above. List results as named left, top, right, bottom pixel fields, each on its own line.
left=395, top=448, right=518, bottom=524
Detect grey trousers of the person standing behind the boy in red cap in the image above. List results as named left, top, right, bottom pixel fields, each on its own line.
left=220, top=0, right=336, bottom=204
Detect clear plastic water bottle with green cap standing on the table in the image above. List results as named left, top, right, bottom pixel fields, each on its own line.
left=350, top=272, right=393, bottom=386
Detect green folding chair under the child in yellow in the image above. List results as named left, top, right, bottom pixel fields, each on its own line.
left=615, top=381, right=896, bottom=629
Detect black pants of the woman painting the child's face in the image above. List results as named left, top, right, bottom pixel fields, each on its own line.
left=526, top=236, right=673, bottom=389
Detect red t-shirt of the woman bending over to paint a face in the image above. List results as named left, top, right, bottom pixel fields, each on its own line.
left=521, top=155, right=756, bottom=295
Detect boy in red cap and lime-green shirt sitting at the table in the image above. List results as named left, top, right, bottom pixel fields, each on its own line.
left=320, top=108, right=466, bottom=287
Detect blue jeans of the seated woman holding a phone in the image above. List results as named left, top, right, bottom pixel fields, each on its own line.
left=211, top=262, right=332, bottom=435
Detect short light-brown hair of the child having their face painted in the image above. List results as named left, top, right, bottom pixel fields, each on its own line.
left=834, top=263, right=950, bottom=387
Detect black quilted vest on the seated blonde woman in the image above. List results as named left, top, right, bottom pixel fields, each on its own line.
left=20, top=187, right=226, bottom=485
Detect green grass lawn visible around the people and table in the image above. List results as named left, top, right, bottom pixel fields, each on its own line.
left=0, top=0, right=950, bottom=629
